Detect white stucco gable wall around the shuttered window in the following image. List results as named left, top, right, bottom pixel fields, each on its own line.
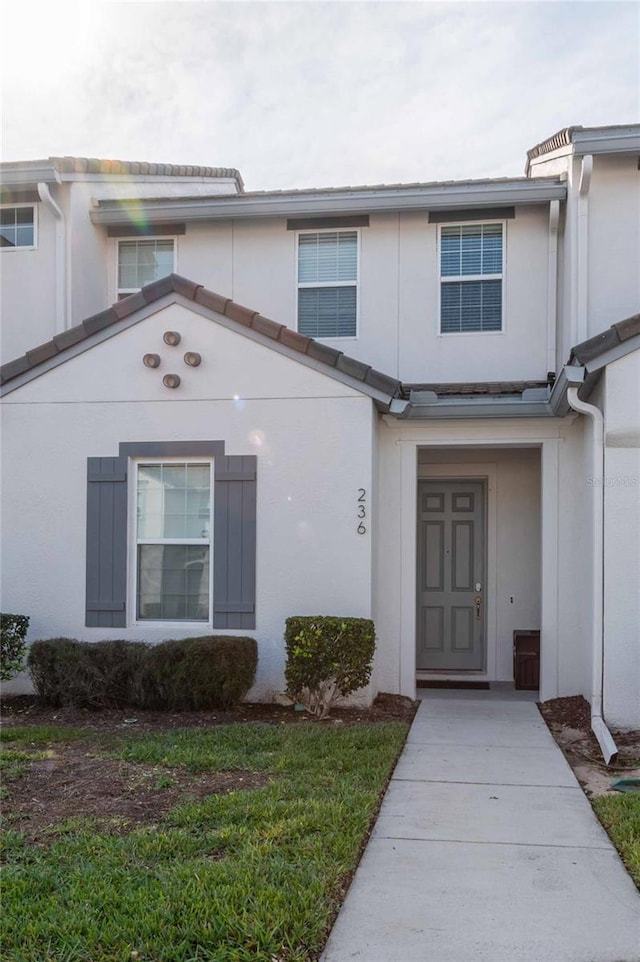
left=1, top=305, right=374, bottom=698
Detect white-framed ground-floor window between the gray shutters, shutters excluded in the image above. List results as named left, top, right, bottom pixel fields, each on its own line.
left=135, top=461, right=213, bottom=622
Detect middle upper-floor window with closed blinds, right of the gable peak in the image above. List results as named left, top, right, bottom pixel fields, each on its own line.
left=298, top=230, right=358, bottom=338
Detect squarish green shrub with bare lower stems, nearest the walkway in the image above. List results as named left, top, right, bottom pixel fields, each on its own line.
left=285, top=615, right=375, bottom=718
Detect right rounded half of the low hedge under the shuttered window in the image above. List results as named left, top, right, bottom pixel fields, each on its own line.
left=143, top=635, right=258, bottom=711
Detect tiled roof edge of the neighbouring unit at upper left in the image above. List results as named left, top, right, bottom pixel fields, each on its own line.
left=0, top=157, right=244, bottom=192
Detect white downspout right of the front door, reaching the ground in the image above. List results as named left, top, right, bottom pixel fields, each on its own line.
left=567, top=387, right=618, bottom=765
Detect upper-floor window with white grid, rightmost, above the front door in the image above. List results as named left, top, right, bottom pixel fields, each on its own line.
left=440, top=224, right=503, bottom=334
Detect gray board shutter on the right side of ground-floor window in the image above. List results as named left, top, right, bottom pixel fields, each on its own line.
left=213, top=455, right=257, bottom=628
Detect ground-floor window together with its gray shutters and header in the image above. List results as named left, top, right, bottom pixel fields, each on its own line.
left=85, top=440, right=257, bottom=629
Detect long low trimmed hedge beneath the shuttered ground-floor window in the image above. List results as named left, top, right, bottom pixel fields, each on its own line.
left=27, top=635, right=258, bottom=711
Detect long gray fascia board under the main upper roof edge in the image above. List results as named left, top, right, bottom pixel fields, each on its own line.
left=91, top=178, right=567, bottom=226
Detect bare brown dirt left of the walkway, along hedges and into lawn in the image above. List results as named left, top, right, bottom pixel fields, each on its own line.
left=2, top=695, right=417, bottom=844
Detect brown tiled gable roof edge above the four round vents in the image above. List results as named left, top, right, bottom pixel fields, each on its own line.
left=0, top=274, right=401, bottom=405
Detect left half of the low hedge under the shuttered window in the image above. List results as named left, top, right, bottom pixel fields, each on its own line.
left=27, top=638, right=147, bottom=708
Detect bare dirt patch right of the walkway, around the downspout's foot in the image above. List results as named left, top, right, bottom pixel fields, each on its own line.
left=540, top=695, right=640, bottom=795
